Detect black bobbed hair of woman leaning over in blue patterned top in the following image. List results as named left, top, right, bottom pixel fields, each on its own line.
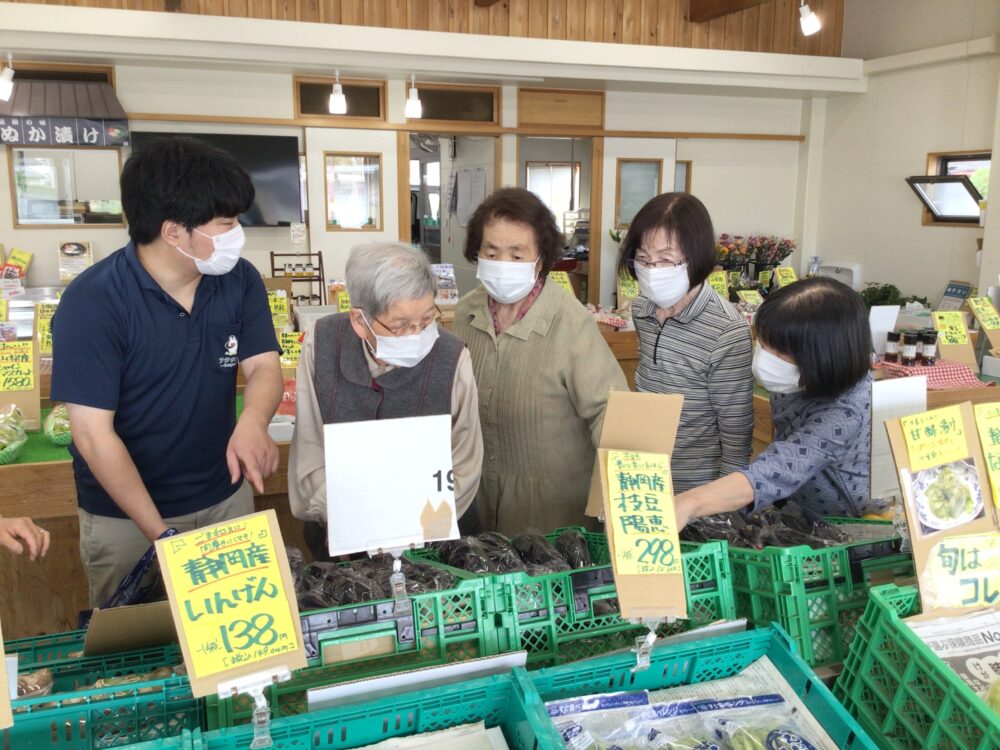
left=754, top=276, right=872, bottom=398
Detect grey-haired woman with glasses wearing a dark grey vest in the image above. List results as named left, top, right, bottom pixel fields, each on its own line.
left=288, top=244, right=483, bottom=560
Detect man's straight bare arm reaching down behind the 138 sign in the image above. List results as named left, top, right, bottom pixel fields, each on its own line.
left=67, top=404, right=167, bottom=544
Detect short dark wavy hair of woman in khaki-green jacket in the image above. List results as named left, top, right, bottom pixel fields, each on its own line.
left=465, top=188, right=563, bottom=278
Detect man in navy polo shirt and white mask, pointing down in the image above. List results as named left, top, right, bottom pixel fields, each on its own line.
left=52, top=138, right=282, bottom=606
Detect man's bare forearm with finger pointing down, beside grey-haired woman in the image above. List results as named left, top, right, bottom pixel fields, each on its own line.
left=226, top=352, right=283, bottom=492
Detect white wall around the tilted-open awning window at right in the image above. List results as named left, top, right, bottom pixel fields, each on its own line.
left=817, top=57, right=1000, bottom=303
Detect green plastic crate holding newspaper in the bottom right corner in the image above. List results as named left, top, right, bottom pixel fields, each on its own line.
left=835, top=585, right=1000, bottom=750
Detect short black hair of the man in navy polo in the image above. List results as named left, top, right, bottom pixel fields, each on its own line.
left=120, top=136, right=254, bottom=245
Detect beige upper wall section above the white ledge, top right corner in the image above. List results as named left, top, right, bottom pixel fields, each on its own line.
left=843, top=0, right=1000, bottom=60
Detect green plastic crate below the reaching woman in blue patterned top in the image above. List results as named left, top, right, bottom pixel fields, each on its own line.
left=729, top=518, right=913, bottom=667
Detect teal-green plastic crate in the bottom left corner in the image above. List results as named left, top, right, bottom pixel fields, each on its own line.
left=0, top=677, right=203, bottom=750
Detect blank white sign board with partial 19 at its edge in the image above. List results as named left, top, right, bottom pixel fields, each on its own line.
left=323, top=414, right=458, bottom=555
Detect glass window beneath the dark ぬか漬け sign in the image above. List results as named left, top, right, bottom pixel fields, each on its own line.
left=10, top=148, right=124, bottom=226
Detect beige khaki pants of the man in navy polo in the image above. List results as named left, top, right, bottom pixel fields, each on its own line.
left=77, top=482, right=254, bottom=607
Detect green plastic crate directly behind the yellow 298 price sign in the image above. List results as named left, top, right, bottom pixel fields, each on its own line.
left=407, top=528, right=735, bottom=668
